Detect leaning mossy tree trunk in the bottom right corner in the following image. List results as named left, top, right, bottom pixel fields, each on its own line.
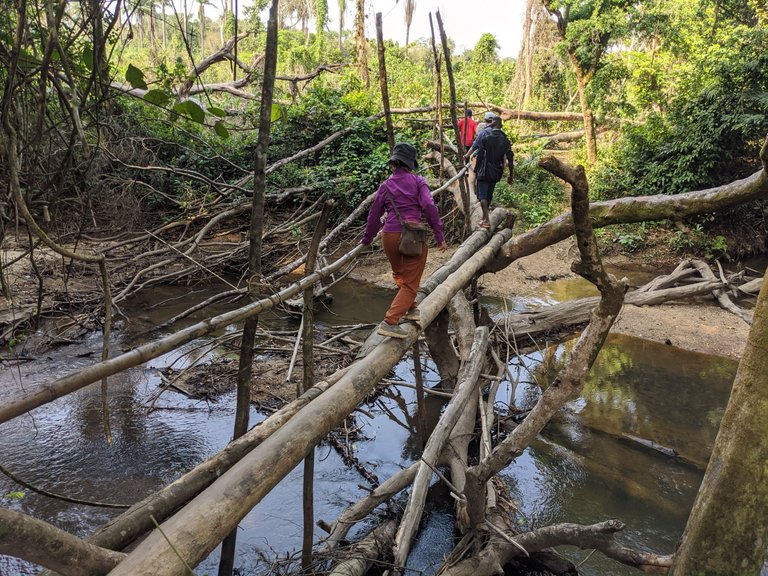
left=671, top=272, right=768, bottom=576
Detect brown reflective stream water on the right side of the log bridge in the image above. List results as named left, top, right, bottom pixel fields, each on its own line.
left=504, top=335, right=737, bottom=574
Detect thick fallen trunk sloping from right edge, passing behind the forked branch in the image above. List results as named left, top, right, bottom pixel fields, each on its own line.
left=483, top=139, right=768, bottom=273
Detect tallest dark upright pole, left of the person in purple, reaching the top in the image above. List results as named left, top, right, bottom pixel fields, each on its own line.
left=219, top=0, right=278, bottom=576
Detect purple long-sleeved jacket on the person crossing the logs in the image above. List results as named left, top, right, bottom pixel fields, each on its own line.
left=361, top=168, right=445, bottom=246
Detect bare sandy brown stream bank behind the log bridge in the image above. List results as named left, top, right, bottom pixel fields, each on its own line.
left=353, top=240, right=749, bottom=358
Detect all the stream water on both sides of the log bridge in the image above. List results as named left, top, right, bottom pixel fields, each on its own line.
left=0, top=282, right=736, bottom=576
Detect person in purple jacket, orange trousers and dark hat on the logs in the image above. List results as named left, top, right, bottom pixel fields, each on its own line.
left=360, top=143, right=448, bottom=338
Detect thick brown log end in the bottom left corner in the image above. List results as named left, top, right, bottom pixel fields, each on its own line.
left=0, top=508, right=125, bottom=576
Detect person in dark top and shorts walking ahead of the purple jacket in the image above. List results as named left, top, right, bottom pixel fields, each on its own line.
left=472, top=116, right=515, bottom=228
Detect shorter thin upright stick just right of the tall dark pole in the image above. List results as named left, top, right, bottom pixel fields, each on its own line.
left=296, top=201, right=334, bottom=572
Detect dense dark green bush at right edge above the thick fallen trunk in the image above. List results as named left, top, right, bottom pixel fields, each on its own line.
left=591, top=29, right=768, bottom=199
